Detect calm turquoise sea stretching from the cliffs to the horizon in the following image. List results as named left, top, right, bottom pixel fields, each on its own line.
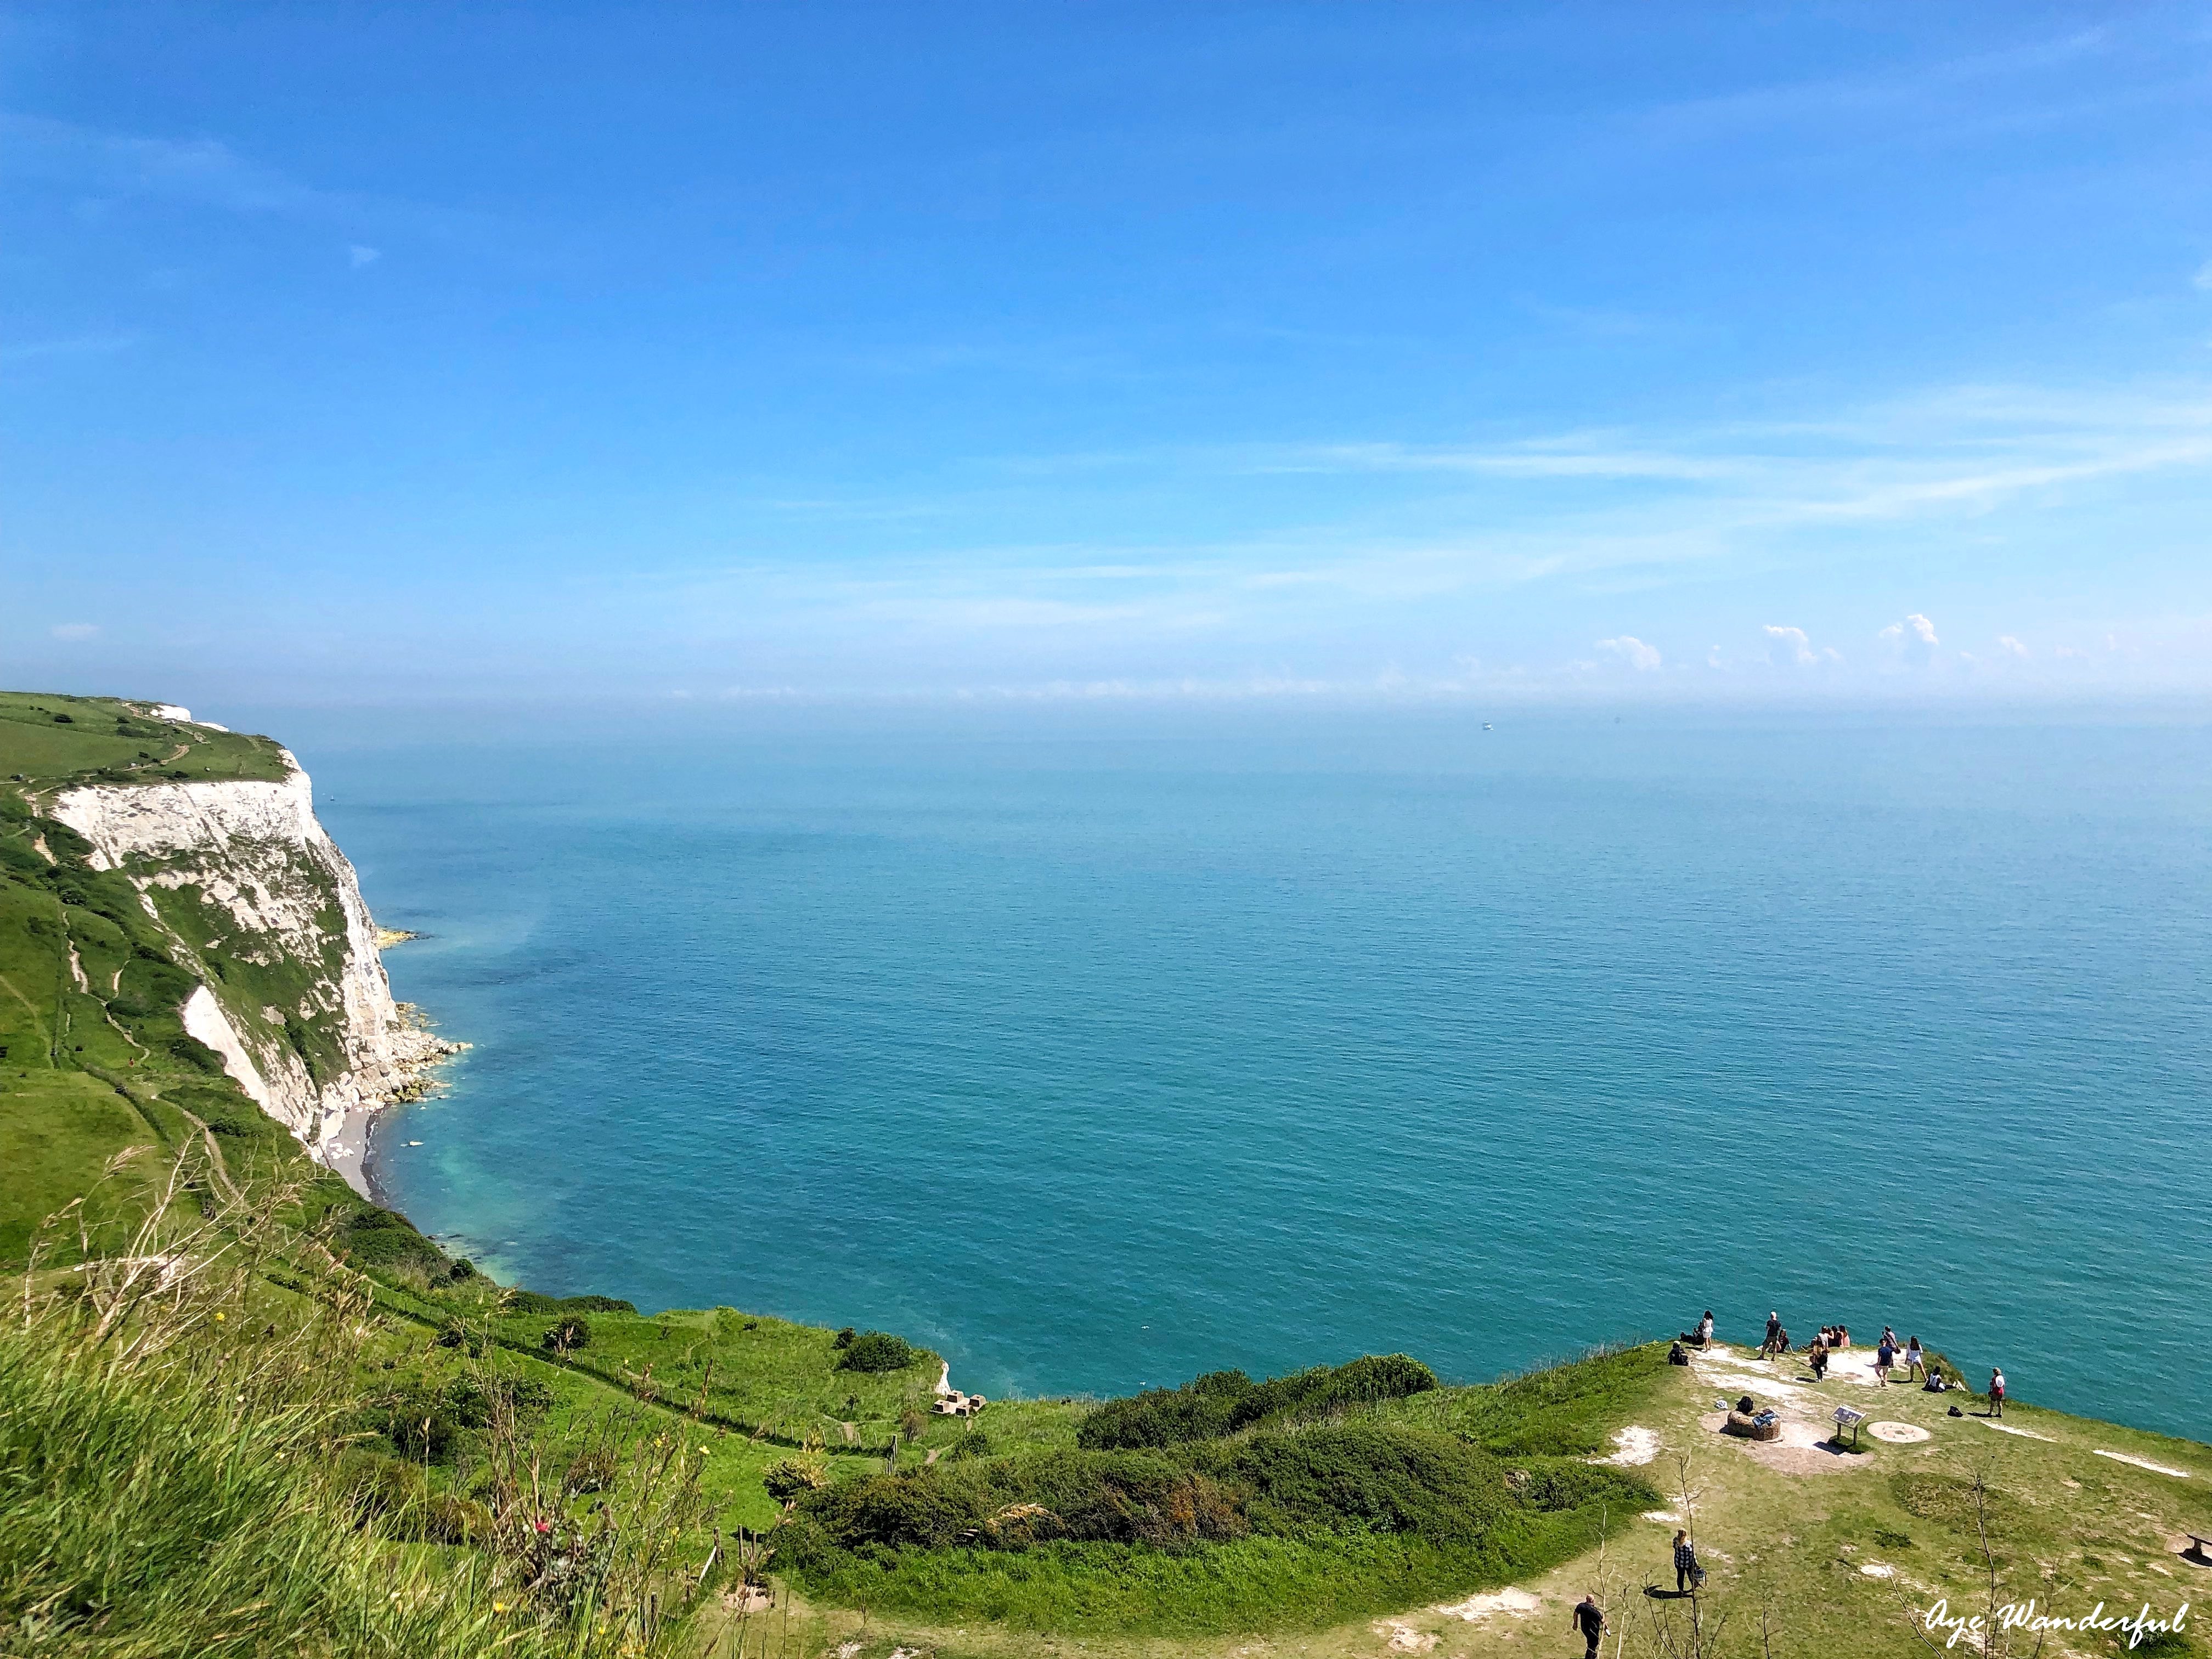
left=298, top=710, right=2212, bottom=1436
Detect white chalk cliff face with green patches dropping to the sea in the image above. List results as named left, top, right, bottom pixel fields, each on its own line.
left=53, top=754, right=452, bottom=1146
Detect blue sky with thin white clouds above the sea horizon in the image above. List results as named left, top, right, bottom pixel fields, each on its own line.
left=0, top=4, right=2212, bottom=703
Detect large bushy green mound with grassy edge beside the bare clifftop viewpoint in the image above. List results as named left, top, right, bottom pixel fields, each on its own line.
left=776, top=1420, right=1657, bottom=1633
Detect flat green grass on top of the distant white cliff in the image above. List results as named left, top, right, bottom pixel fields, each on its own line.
left=0, top=692, right=285, bottom=787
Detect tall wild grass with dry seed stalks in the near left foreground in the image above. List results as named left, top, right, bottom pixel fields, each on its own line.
left=0, top=1161, right=712, bottom=1659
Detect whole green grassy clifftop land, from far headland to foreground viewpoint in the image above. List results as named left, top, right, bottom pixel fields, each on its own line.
left=0, top=695, right=2212, bottom=1659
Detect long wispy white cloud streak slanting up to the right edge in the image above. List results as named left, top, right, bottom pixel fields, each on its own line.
left=619, top=383, right=2212, bottom=684
